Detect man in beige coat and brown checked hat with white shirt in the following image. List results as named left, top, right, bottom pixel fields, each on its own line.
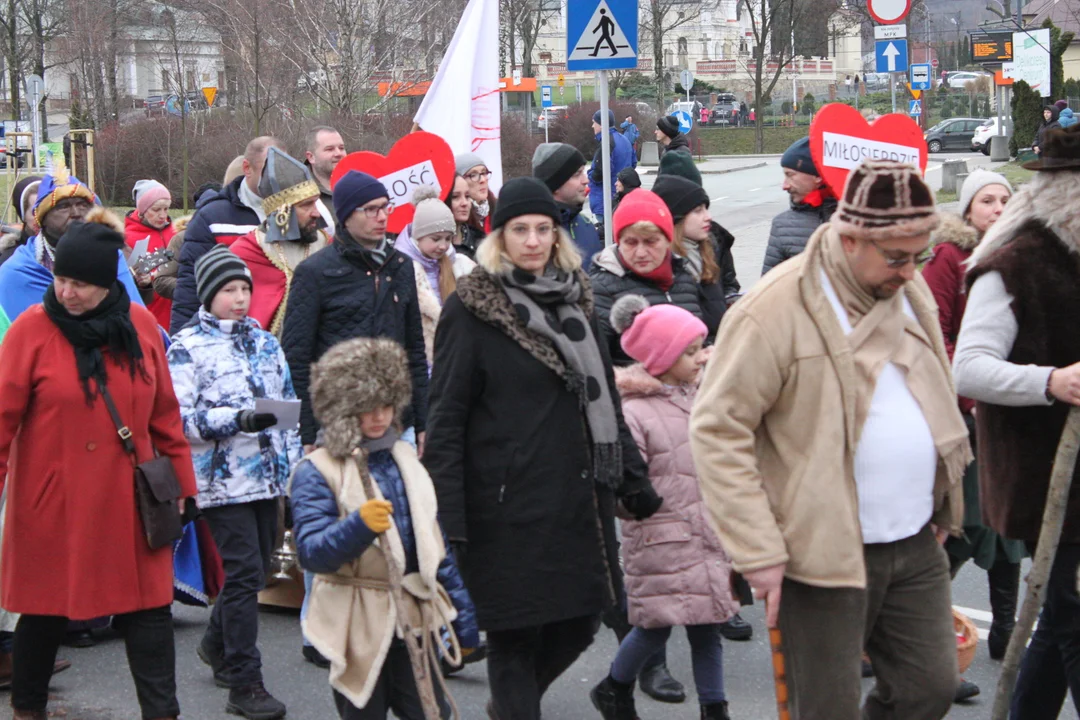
left=691, top=160, right=972, bottom=720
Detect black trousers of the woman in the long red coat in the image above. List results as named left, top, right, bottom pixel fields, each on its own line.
left=11, top=606, right=180, bottom=720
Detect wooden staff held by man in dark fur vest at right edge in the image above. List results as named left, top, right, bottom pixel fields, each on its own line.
left=991, top=406, right=1080, bottom=720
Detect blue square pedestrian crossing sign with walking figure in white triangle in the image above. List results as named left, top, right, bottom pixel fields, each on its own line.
left=566, top=0, right=637, bottom=71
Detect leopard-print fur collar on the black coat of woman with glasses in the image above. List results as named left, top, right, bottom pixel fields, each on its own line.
left=458, top=266, right=599, bottom=380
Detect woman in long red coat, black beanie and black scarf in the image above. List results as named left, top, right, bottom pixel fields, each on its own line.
left=0, top=209, right=195, bottom=720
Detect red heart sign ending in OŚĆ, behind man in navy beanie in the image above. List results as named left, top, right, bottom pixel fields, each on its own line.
left=330, top=132, right=456, bottom=233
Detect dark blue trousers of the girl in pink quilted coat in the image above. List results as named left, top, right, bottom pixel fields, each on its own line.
left=611, top=625, right=727, bottom=705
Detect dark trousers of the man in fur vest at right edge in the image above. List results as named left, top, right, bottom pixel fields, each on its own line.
left=1009, top=544, right=1080, bottom=720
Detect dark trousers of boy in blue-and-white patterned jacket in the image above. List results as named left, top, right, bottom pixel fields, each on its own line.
left=203, top=500, right=278, bottom=688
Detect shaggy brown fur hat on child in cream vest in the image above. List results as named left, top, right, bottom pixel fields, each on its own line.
left=311, top=338, right=413, bottom=458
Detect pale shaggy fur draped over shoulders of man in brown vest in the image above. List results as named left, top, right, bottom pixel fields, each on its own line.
left=968, top=171, right=1080, bottom=268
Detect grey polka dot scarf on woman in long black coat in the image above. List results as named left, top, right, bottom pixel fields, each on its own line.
left=500, top=267, right=622, bottom=488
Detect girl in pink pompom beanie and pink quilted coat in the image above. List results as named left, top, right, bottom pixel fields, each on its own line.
left=590, top=295, right=739, bottom=720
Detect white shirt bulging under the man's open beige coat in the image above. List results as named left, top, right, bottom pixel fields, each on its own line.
left=821, top=271, right=937, bottom=543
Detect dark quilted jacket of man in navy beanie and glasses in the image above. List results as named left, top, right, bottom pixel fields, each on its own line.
left=281, top=235, right=428, bottom=445
